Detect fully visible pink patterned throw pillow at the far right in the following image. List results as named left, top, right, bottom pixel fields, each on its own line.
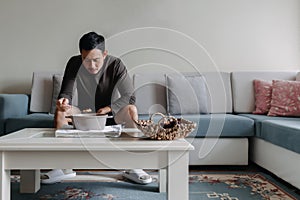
left=268, top=80, right=300, bottom=116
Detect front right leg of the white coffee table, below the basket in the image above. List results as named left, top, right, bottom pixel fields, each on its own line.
left=167, top=151, right=189, bottom=200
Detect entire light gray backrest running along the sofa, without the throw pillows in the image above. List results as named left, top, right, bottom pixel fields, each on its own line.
left=30, top=71, right=297, bottom=114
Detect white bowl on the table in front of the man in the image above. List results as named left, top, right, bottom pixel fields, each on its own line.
left=72, top=113, right=108, bottom=131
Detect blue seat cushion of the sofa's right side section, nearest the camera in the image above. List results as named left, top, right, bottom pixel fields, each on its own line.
left=260, top=120, right=300, bottom=153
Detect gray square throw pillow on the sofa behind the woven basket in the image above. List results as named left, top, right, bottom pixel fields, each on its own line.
left=166, top=74, right=208, bottom=114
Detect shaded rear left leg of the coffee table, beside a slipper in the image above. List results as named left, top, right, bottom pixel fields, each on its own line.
left=20, top=170, right=41, bottom=193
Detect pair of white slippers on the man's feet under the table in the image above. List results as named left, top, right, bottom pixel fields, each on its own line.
left=41, top=169, right=152, bottom=184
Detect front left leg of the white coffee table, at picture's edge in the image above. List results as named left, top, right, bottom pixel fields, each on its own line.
left=0, top=152, right=10, bottom=200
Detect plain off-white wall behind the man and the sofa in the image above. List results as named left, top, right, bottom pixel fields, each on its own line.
left=0, top=0, right=300, bottom=93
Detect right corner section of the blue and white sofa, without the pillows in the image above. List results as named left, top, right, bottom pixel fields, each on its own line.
left=231, top=71, right=300, bottom=188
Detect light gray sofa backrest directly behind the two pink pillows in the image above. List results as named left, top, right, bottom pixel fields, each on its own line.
left=231, top=71, right=297, bottom=113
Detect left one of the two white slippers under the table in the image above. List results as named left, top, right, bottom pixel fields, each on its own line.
left=41, top=169, right=76, bottom=184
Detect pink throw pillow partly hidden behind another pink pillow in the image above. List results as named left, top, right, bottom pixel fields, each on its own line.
left=252, top=79, right=272, bottom=115
